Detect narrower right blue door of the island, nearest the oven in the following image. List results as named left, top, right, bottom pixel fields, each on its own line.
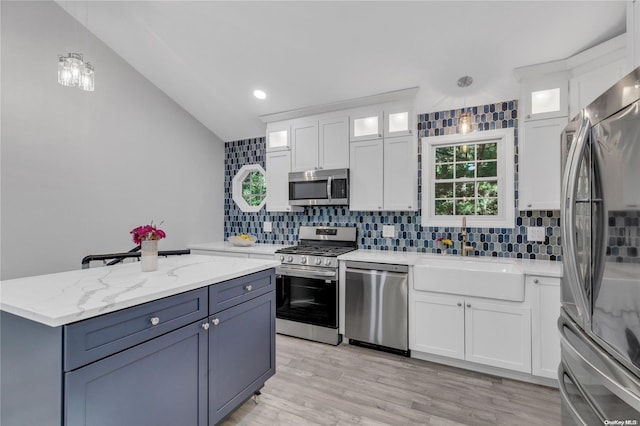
left=209, top=291, right=275, bottom=424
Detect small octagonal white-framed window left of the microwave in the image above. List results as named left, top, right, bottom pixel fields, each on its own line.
left=232, top=164, right=267, bottom=212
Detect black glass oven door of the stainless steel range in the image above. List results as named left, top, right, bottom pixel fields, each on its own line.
left=276, top=266, right=338, bottom=329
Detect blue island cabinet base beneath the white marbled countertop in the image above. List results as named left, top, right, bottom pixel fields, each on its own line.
left=0, top=269, right=275, bottom=426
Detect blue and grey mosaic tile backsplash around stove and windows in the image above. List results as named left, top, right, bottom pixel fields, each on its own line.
left=224, top=100, right=561, bottom=260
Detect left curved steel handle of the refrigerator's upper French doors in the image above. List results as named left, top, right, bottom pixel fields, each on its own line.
left=561, top=114, right=591, bottom=325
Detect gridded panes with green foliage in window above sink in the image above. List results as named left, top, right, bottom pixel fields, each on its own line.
left=434, top=142, right=498, bottom=216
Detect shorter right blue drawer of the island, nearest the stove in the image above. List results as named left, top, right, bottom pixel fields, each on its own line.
left=209, top=269, right=276, bottom=315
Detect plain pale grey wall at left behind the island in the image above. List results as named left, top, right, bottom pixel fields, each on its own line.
left=0, top=1, right=224, bottom=279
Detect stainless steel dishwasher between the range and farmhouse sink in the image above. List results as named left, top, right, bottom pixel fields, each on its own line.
left=345, top=261, right=409, bottom=356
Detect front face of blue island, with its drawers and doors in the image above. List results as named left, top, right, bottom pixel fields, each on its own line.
left=61, top=270, right=275, bottom=426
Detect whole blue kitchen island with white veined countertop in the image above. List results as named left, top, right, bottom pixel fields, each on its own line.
left=0, top=255, right=278, bottom=426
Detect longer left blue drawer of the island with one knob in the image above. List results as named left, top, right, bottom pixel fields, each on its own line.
left=64, top=287, right=207, bottom=371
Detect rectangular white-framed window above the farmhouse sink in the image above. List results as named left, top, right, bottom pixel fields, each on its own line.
left=422, top=129, right=515, bottom=228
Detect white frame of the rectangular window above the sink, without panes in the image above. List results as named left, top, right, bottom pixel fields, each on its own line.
left=422, top=128, right=515, bottom=228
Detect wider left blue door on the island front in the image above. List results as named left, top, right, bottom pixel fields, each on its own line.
left=64, top=321, right=207, bottom=426
